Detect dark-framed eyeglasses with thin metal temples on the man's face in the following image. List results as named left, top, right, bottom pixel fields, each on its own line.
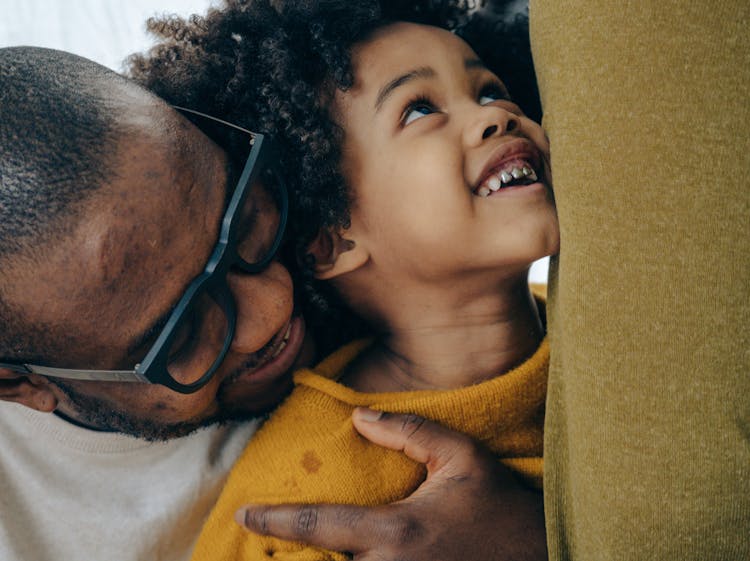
left=0, top=106, right=289, bottom=393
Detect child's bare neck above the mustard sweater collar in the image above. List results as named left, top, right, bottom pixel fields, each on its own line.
left=340, top=282, right=544, bottom=392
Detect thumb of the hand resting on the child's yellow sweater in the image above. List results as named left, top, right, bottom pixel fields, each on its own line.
left=352, top=407, right=479, bottom=477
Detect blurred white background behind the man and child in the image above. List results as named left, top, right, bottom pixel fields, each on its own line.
left=0, top=0, right=549, bottom=282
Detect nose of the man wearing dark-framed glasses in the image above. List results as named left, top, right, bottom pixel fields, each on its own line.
left=227, top=261, right=294, bottom=353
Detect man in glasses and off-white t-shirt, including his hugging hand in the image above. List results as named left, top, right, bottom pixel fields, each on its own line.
left=0, top=48, right=543, bottom=561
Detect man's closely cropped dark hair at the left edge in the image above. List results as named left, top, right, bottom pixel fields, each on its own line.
left=0, top=47, right=125, bottom=360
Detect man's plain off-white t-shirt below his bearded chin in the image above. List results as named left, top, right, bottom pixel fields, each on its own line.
left=0, top=402, right=258, bottom=561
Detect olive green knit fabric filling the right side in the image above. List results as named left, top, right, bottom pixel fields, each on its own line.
left=530, top=0, right=750, bottom=561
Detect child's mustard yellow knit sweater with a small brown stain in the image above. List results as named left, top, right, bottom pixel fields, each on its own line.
left=193, top=339, right=549, bottom=561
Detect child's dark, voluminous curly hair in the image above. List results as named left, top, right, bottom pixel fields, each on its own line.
left=129, top=0, right=540, bottom=352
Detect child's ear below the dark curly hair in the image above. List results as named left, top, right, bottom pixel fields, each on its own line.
left=307, top=228, right=370, bottom=280
